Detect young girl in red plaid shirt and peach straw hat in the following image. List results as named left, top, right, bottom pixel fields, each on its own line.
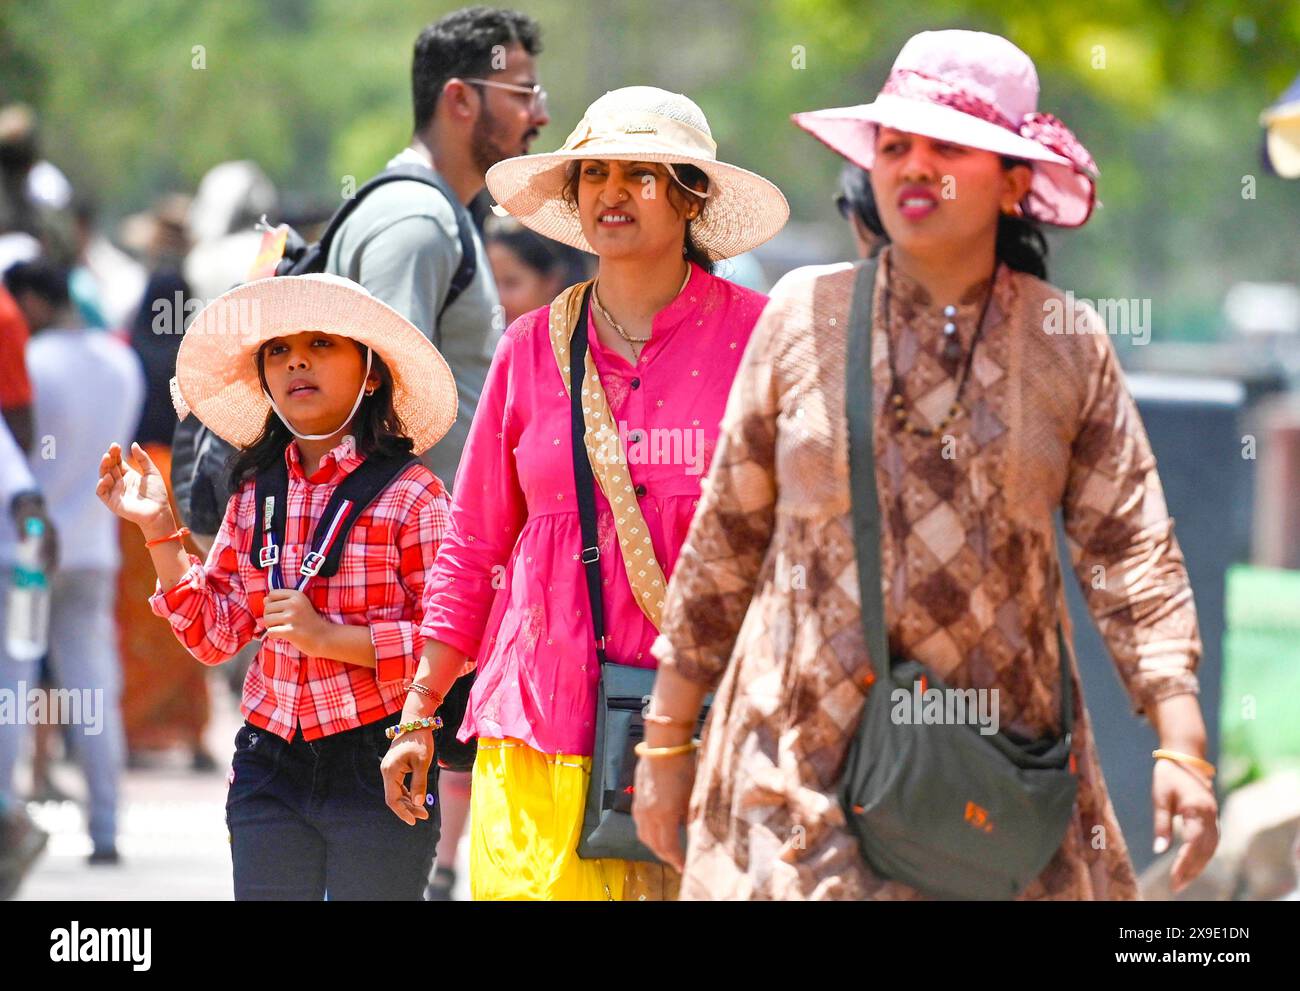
left=96, top=276, right=456, bottom=900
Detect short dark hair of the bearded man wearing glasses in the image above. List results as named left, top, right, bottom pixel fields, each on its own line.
left=411, top=7, right=542, bottom=131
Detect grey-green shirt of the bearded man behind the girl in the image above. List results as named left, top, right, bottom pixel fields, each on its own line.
left=325, top=148, right=504, bottom=489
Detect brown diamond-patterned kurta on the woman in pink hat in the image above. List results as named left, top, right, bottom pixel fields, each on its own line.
left=654, top=248, right=1200, bottom=899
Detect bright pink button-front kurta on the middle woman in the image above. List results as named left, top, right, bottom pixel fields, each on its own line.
left=420, top=265, right=767, bottom=754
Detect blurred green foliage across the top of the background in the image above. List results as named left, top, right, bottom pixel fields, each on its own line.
left=0, top=0, right=1300, bottom=339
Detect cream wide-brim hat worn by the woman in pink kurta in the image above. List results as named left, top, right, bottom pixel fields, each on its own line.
left=488, top=86, right=790, bottom=261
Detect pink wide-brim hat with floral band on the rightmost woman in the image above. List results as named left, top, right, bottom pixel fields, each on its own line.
left=794, top=30, right=1097, bottom=228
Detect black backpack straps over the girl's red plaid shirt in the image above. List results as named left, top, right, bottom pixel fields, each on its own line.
left=250, top=454, right=419, bottom=590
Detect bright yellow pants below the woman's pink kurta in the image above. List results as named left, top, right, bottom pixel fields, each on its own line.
left=469, top=739, right=627, bottom=901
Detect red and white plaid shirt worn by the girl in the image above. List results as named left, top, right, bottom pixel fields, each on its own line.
left=150, top=434, right=450, bottom=740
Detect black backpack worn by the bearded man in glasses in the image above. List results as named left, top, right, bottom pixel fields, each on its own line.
left=172, top=164, right=478, bottom=535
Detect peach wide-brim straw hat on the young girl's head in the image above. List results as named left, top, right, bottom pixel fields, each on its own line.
left=172, top=274, right=456, bottom=454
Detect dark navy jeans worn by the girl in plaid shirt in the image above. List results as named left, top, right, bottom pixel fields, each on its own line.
left=226, top=715, right=441, bottom=901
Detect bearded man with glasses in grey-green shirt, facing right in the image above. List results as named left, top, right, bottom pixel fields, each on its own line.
left=326, top=7, right=550, bottom=489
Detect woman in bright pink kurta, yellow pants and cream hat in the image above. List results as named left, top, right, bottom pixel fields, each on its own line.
left=374, top=87, right=788, bottom=899
